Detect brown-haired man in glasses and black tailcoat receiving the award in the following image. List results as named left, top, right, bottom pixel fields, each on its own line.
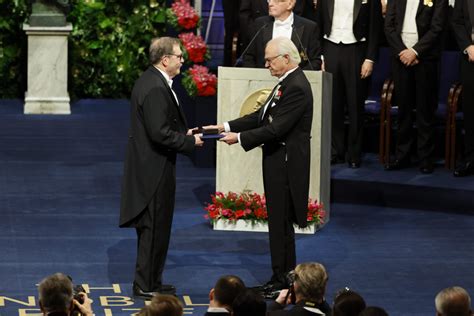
left=120, top=37, right=203, bottom=298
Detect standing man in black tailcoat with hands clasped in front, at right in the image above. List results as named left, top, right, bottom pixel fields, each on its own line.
left=385, top=0, right=448, bottom=174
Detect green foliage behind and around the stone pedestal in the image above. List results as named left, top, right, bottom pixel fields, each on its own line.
left=0, top=0, right=166, bottom=98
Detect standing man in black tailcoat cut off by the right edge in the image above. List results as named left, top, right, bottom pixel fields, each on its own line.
left=452, top=0, right=474, bottom=177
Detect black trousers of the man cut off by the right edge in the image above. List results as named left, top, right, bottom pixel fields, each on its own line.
left=460, top=54, right=474, bottom=162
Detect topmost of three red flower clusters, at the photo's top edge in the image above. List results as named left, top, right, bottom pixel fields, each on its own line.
left=166, top=0, right=201, bottom=30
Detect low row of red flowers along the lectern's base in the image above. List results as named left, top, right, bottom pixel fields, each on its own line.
left=204, top=192, right=326, bottom=225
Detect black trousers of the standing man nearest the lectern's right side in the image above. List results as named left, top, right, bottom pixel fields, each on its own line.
left=323, top=40, right=368, bottom=162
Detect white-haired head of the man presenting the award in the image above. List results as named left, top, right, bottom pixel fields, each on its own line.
left=265, top=37, right=301, bottom=77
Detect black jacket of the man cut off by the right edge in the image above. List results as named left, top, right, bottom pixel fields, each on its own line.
left=452, top=0, right=474, bottom=51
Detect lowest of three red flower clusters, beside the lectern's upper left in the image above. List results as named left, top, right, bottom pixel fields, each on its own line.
left=181, top=65, right=217, bottom=97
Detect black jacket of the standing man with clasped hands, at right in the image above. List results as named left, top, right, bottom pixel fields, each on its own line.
left=385, top=0, right=448, bottom=60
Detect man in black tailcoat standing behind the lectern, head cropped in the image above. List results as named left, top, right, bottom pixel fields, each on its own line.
left=242, top=0, right=321, bottom=70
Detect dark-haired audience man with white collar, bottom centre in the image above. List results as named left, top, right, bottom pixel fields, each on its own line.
left=205, top=275, right=245, bottom=316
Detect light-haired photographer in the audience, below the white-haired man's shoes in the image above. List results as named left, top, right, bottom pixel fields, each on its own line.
left=268, top=262, right=331, bottom=316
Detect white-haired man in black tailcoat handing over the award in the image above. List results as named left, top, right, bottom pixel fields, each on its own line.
left=210, top=37, right=313, bottom=291
